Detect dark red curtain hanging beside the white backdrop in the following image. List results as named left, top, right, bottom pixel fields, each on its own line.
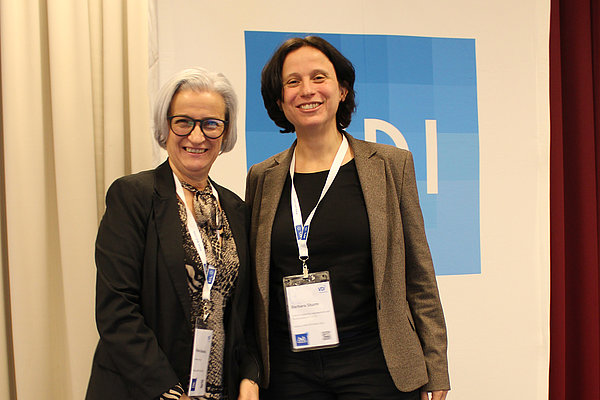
left=549, top=0, right=600, bottom=400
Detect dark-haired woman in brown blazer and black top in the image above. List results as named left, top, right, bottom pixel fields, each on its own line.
left=246, top=36, right=450, bottom=400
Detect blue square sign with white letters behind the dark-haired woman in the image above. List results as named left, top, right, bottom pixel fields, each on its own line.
left=245, top=31, right=481, bottom=275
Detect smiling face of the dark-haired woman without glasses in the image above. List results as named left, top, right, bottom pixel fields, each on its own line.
left=279, top=46, right=347, bottom=133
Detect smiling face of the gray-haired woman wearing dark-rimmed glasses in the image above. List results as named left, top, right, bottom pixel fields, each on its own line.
left=167, top=90, right=227, bottom=187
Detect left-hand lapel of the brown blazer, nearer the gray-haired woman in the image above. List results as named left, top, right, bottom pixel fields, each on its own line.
left=256, top=148, right=295, bottom=301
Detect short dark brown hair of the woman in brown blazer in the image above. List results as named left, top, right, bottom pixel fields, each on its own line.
left=260, top=36, right=356, bottom=133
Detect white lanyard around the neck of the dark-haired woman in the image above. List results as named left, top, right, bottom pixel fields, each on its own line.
left=290, top=135, right=348, bottom=277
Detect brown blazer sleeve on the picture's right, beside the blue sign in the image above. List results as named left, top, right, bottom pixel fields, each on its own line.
left=399, top=152, right=450, bottom=391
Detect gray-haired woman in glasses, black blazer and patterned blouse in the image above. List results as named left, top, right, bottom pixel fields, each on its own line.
left=86, top=68, right=261, bottom=400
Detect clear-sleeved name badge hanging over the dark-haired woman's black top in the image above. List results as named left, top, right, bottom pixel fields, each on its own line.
left=283, top=271, right=339, bottom=351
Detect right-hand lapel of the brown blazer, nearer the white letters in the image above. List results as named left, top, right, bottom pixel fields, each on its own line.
left=346, top=135, right=389, bottom=292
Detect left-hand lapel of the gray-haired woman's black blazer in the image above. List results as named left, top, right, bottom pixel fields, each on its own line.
left=154, top=160, right=192, bottom=326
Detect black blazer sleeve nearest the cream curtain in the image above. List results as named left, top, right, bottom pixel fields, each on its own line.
left=96, top=177, right=179, bottom=399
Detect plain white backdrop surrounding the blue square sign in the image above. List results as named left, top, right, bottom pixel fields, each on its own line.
left=157, top=0, right=550, bottom=400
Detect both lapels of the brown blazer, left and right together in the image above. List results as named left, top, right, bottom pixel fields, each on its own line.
left=256, top=132, right=393, bottom=298
